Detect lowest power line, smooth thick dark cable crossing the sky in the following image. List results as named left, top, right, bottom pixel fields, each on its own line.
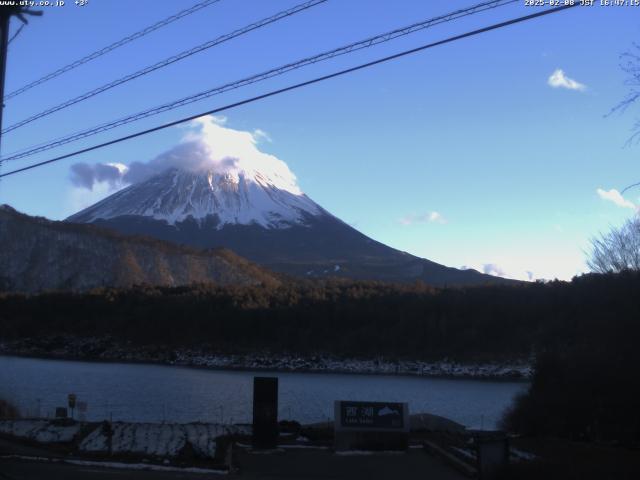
left=0, top=3, right=579, bottom=178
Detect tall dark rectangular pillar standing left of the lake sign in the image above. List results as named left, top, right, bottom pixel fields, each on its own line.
left=253, top=377, right=278, bottom=448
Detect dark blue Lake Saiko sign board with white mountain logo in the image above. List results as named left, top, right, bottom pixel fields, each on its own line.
left=334, top=401, right=410, bottom=451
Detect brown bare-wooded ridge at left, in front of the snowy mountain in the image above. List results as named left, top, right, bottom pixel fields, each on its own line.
left=0, top=205, right=280, bottom=293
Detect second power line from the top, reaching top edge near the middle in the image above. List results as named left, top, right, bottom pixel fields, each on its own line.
left=2, top=0, right=327, bottom=134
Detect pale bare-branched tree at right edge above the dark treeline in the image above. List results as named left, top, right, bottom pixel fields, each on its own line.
left=587, top=215, right=640, bottom=273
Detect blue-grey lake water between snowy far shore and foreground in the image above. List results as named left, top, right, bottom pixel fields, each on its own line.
left=0, top=356, right=528, bottom=429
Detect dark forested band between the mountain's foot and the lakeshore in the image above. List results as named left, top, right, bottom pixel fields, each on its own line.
left=0, top=273, right=640, bottom=360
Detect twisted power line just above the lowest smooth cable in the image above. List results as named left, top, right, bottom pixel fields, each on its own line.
left=2, top=0, right=519, bottom=161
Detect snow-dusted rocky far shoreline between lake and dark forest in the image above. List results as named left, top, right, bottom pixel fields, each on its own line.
left=0, top=336, right=533, bottom=381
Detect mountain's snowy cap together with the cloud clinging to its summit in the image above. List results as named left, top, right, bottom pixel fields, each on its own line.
left=69, top=117, right=326, bottom=229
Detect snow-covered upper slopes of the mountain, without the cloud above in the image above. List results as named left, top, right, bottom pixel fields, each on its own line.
left=69, top=167, right=326, bottom=228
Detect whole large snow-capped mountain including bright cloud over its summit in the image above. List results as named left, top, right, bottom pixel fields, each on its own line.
left=67, top=120, right=508, bottom=285
